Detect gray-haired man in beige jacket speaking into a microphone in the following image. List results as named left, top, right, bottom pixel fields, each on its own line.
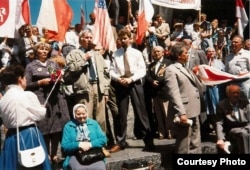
left=64, top=30, right=110, bottom=131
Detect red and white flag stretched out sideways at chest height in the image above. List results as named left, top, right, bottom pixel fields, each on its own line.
left=195, top=64, right=250, bottom=85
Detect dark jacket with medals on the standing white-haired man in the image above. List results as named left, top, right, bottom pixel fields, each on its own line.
left=146, top=58, right=172, bottom=100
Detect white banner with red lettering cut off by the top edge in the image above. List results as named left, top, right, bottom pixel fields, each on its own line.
left=151, top=0, right=201, bottom=10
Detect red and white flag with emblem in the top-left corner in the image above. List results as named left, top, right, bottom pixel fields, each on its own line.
left=0, top=0, right=30, bottom=38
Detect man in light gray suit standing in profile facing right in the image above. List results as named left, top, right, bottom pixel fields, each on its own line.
left=165, top=42, right=202, bottom=154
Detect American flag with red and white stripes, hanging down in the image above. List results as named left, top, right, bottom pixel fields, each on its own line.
left=93, top=0, right=116, bottom=51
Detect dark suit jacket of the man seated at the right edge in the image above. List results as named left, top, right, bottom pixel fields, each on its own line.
left=216, top=98, right=250, bottom=140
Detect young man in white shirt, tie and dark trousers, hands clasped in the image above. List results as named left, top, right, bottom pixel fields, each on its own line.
left=110, top=29, right=154, bottom=153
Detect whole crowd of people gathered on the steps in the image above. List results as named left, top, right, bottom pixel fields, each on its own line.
left=0, top=8, right=250, bottom=169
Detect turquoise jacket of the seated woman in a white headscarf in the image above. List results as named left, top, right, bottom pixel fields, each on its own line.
left=61, top=118, right=107, bottom=169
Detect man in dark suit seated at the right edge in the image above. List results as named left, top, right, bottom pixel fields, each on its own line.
left=216, top=84, right=250, bottom=154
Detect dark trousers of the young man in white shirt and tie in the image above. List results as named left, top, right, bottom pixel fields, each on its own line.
left=114, top=81, right=153, bottom=147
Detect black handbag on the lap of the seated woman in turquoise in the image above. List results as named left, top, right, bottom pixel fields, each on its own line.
left=75, top=148, right=105, bottom=165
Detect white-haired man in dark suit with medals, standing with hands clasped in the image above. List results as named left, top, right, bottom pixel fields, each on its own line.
left=146, top=46, right=171, bottom=139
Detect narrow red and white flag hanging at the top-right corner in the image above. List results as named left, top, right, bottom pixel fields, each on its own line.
left=236, top=0, right=248, bottom=37
